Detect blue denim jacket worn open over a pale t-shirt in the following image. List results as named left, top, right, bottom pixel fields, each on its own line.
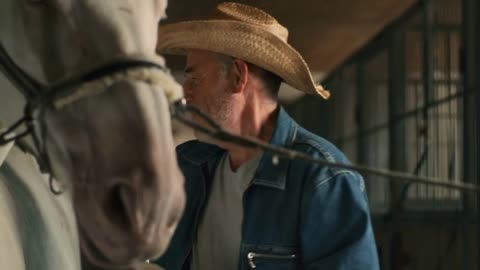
left=156, top=108, right=379, bottom=270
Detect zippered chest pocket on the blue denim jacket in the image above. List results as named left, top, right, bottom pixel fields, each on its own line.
left=242, top=247, right=299, bottom=270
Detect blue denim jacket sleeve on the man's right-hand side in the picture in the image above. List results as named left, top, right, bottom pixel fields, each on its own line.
left=301, top=171, right=379, bottom=270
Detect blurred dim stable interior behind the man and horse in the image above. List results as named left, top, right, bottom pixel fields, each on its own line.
left=167, top=0, right=480, bottom=270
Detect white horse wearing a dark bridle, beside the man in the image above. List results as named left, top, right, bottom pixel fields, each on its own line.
left=0, top=0, right=185, bottom=270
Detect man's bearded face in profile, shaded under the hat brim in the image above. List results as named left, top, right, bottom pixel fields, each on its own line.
left=183, top=50, right=233, bottom=141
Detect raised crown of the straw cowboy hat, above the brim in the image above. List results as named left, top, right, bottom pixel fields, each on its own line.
left=209, top=2, right=288, bottom=42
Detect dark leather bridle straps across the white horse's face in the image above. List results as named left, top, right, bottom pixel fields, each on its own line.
left=0, top=44, right=178, bottom=194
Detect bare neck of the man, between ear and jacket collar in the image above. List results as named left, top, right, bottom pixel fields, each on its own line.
left=224, top=102, right=279, bottom=171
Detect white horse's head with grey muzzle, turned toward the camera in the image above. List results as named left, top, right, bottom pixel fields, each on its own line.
left=0, top=0, right=185, bottom=266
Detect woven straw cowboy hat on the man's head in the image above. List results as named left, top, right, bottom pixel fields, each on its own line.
left=157, top=2, right=330, bottom=99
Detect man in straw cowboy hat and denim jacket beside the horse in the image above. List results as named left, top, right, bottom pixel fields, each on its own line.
left=157, top=3, right=379, bottom=270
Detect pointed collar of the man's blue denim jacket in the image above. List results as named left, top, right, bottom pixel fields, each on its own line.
left=180, top=106, right=298, bottom=190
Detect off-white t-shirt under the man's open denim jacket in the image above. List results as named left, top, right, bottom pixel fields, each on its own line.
left=192, top=154, right=261, bottom=270
